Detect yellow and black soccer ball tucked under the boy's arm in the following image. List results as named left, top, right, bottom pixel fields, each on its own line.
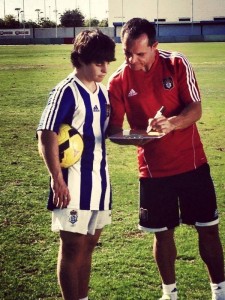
left=58, top=124, right=84, bottom=168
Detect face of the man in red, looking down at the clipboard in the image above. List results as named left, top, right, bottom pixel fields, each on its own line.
left=122, top=33, right=158, bottom=72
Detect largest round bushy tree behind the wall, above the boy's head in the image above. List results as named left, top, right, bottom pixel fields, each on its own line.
left=60, top=8, right=84, bottom=27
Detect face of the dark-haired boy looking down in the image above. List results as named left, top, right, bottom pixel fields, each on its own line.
left=79, top=61, right=109, bottom=82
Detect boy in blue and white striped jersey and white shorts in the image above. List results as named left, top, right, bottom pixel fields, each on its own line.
left=37, top=30, right=115, bottom=300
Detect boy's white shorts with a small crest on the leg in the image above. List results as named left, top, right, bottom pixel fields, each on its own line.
left=52, top=208, right=112, bottom=235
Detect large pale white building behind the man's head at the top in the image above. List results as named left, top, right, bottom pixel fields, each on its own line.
left=108, top=0, right=225, bottom=26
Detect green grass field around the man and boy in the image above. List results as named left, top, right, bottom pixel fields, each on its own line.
left=0, top=43, right=225, bottom=300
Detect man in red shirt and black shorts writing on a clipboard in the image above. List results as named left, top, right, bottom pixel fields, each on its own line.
left=109, top=18, right=225, bottom=300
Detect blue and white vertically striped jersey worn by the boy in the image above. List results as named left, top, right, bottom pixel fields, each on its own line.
left=37, top=72, right=111, bottom=210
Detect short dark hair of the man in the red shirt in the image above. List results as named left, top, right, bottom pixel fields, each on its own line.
left=121, top=18, right=156, bottom=46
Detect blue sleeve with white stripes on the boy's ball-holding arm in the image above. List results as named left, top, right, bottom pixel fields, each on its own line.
left=37, top=85, right=75, bottom=133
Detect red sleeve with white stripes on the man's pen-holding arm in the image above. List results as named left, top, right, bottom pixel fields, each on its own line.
left=176, top=54, right=201, bottom=104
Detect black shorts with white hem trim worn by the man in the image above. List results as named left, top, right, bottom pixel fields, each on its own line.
left=139, top=164, right=218, bottom=232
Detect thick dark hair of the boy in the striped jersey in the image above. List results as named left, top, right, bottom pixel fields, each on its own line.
left=71, top=29, right=115, bottom=68
